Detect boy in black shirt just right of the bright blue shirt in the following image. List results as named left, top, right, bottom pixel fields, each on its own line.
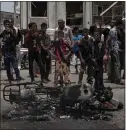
left=78, top=26, right=95, bottom=85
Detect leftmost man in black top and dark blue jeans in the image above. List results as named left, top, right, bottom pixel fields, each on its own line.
left=0, top=20, right=21, bottom=83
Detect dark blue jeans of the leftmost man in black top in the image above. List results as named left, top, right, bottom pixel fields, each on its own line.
left=4, top=53, right=20, bottom=81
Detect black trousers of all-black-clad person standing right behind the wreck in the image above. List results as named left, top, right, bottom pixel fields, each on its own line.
left=94, top=59, right=104, bottom=90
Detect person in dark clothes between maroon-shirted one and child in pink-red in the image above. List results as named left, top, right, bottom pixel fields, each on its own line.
left=40, top=23, right=51, bottom=82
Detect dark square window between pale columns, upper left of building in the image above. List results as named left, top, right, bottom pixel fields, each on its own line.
left=31, top=1, right=47, bottom=17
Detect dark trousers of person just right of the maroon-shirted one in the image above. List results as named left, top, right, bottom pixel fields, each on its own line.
left=41, top=53, right=51, bottom=79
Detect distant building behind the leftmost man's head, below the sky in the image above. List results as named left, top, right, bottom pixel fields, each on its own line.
left=0, top=11, right=20, bottom=32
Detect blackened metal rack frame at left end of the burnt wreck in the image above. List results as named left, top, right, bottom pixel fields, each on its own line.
left=3, top=82, right=75, bottom=104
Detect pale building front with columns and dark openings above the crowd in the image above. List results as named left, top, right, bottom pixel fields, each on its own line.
left=20, top=1, right=125, bottom=29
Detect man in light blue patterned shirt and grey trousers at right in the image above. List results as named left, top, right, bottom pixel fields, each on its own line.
left=106, top=19, right=123, bottom=84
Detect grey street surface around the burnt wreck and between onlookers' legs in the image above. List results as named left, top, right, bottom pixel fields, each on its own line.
left=1, top=63, right=125, bottom=129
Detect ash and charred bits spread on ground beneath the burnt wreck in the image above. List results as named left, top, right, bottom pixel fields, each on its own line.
left=2, top=98, right=113, bottom=121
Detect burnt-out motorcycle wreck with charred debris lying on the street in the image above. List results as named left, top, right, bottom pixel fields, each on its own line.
left=3, top=82, right=123, bottom=121
